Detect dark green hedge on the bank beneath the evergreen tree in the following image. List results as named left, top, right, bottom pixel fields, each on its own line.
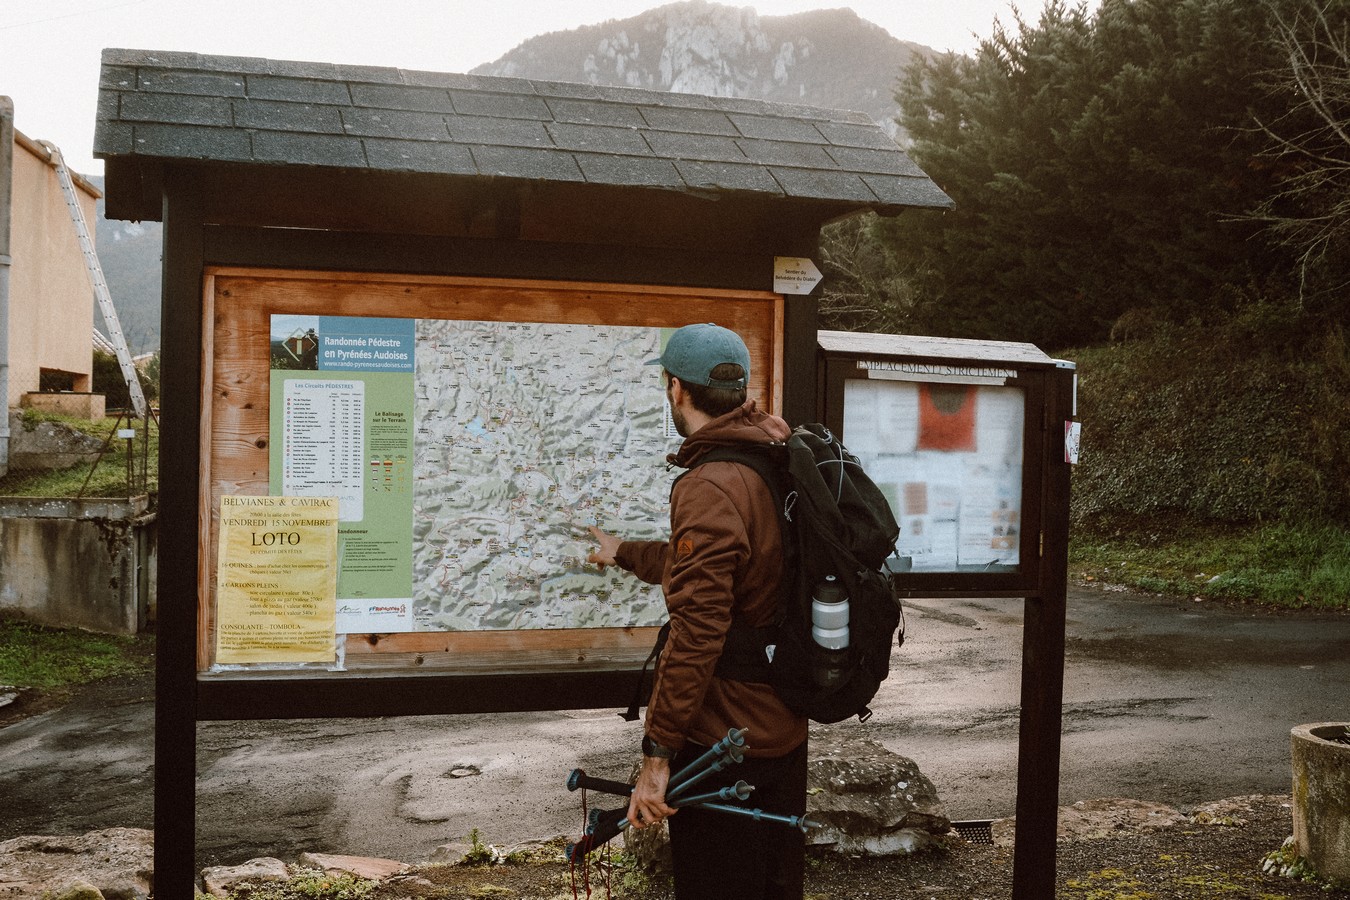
left=1064, top=304, right=1350, bottom=529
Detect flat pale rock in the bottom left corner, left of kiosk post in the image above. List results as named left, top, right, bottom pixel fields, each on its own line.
left=0, top=828, right=154, bottom=900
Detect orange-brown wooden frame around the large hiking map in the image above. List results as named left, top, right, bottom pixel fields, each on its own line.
left=197, top=267, right=784, bottom=679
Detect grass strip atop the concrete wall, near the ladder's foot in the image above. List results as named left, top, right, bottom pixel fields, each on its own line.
left=0, top=409, right=159, bottom=498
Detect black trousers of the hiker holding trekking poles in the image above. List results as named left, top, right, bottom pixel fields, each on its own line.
left=667, top=741, right=806, bottom=900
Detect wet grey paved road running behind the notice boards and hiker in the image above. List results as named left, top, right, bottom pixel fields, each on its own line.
left=0, top=588, right=1350, bottom=865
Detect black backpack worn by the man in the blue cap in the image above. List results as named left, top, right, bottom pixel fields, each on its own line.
left=625, top=425, right=905, bottom=723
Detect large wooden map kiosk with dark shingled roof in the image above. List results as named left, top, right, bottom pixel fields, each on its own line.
left=95, top=50, right=1069, bottom=891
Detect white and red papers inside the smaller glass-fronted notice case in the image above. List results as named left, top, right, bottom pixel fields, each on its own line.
left=844, top=378, right=1026, bottom=572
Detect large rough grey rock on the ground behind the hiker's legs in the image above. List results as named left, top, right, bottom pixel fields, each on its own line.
left=806, top=729, right=952, bottom=855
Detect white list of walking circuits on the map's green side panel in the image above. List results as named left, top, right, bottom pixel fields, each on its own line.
left=282, top=378, right=366, bottom=522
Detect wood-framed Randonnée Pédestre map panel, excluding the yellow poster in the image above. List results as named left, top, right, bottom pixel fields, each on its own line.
left=197, top=267, right=784, bottom=680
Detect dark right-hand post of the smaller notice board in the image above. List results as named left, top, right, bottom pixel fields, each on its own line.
left=1013, top=363, right=1075, bottom=900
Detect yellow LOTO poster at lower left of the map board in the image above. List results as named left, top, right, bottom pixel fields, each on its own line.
left=216, top=497, right=339, bottom=665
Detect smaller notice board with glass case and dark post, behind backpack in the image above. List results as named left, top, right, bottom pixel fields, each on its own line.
left=818, top=332, right=1079, bottom=899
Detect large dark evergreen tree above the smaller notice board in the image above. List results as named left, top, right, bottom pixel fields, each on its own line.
left=878, top=0, right=1287, bottom=349
